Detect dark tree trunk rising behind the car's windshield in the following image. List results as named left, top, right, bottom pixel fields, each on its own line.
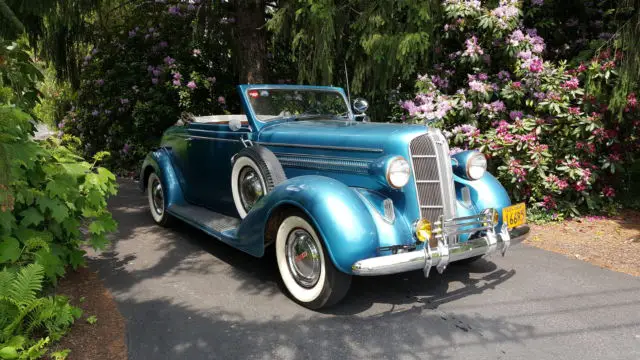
left=235, top=0, right=267, bottom=84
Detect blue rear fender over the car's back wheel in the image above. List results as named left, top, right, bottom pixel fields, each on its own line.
left=140, top=148, right=185, bottom=208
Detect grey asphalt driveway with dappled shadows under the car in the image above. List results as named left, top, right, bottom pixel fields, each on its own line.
left=91, top=181, right=640, bottom=360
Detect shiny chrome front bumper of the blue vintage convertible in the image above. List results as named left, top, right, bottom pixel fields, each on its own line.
left=351, top=225, right=529, bottom=277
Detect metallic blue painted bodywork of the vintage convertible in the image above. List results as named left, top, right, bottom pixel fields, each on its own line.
left=141, top=85, right=511, bottom=273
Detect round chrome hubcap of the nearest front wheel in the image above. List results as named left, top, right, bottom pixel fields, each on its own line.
left=286, top=228, right=322, bottom=288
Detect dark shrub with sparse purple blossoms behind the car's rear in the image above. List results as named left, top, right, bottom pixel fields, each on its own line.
left=60, top=1, right=239, bottom=170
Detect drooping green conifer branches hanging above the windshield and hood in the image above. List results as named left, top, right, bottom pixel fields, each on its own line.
left=268, top=0, right=439, bottom=121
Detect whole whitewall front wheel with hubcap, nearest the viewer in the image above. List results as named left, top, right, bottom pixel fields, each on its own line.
left=275, top=212, right=351, bottom=309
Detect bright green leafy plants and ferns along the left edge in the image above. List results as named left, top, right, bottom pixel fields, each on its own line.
left=0, top=41, right=116, bottom=359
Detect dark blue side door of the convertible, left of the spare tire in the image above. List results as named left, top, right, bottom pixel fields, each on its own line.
left=186, top=121, right=251, bottom=216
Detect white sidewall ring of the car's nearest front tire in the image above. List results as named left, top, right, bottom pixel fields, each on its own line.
left=275, top=215, right=330, bottom=308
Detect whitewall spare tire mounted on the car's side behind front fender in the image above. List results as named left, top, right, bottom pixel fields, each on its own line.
left=231, top=146, right=287, bottom=219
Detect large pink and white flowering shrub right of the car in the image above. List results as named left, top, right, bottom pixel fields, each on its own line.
left=400, top=0, right=640, bottom=215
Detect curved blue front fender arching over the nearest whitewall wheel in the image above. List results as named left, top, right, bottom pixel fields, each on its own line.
left=237, top=175, right=378, bottom=273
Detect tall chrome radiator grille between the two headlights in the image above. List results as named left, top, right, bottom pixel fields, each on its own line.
left=409, top=129, right=456, bottom=242
